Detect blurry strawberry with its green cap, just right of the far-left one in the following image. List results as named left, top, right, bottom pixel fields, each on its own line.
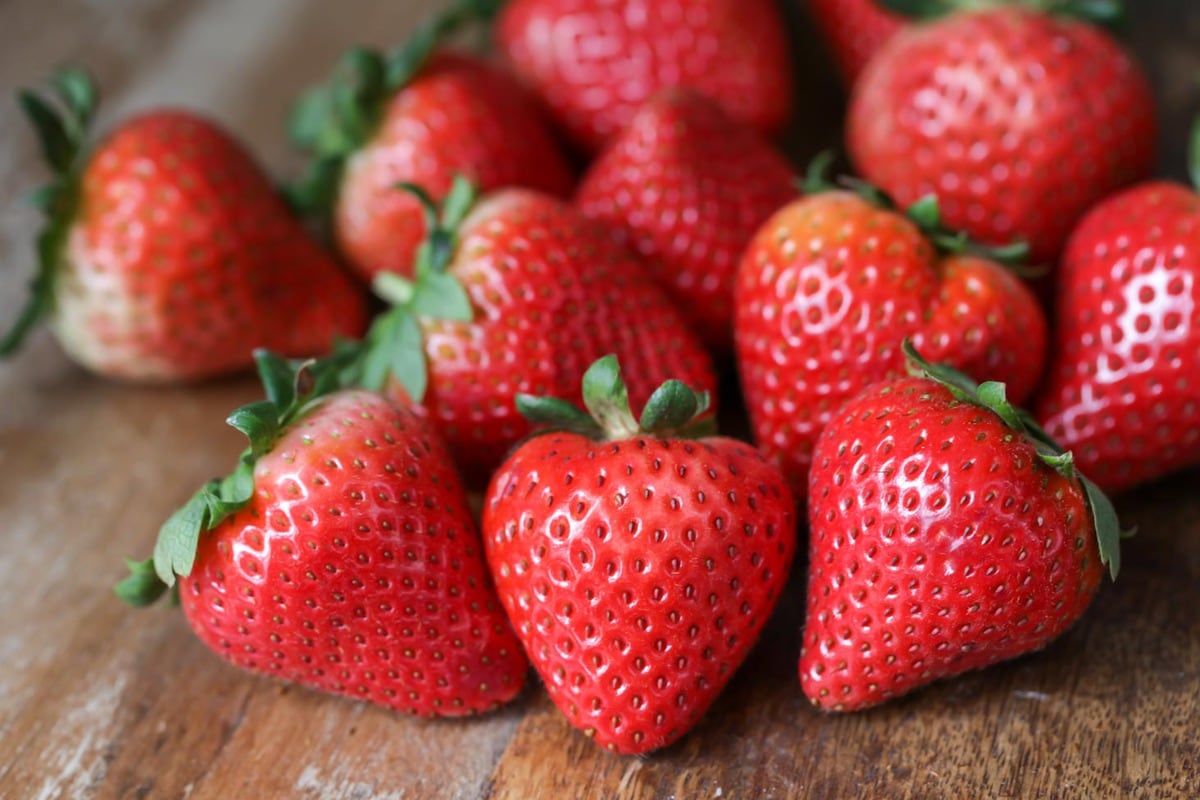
left=293, top=0, right=574, bottom=278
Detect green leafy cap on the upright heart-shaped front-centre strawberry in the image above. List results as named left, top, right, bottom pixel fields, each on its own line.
left=516, top=355, right=714, bottom=441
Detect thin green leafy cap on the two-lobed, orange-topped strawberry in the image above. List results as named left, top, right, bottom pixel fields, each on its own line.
left=800, top=151, right=1027, bottom=278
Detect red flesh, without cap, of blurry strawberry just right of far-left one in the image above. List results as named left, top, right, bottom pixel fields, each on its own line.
left=334, top=53, right=574, bottom=279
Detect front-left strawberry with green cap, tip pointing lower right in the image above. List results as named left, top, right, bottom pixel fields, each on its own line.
left=118, top=353, right=527, bottom=716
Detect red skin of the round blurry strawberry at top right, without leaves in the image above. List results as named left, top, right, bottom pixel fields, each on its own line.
left=847, top=7, right=1157, bottom=264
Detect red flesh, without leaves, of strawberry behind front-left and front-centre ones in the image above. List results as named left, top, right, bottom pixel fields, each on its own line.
left=389, top=190, right=716, bottom=483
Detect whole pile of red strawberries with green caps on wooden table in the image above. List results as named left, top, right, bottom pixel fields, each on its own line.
left=0, top=0, right=1200, bottom=754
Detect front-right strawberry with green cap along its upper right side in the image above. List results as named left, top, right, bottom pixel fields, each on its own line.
left=799, top=345, right=1120, bottom=711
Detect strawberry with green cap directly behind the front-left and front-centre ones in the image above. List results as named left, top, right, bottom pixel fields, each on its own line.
left=340, top=180, right=715, bottom=483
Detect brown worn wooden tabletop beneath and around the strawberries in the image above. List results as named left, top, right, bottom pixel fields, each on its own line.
left=0, top=0, right=1200, bottom=800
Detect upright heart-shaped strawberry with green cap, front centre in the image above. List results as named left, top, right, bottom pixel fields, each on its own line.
left=484, top=356, right=796, bottom=753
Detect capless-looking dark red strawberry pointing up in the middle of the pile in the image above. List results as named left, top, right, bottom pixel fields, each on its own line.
left=575, top=90, right=797, bottom=350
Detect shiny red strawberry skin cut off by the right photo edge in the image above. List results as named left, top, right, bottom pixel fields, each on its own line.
left=1037, top=182, right=1200, bottom=492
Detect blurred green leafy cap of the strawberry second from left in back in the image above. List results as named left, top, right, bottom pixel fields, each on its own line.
left=286, top=0, right=503, bottom=216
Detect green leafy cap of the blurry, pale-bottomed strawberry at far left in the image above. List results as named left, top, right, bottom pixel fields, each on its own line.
left=0, top=67, right=98, bottom=356
